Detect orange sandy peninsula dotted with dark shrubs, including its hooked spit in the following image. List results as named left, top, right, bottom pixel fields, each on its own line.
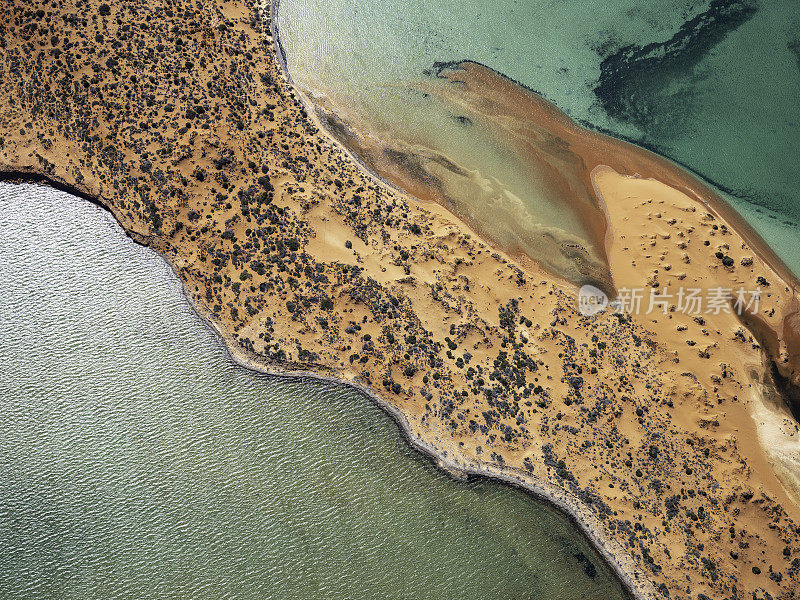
left=0, top=0, right=800, bottom=600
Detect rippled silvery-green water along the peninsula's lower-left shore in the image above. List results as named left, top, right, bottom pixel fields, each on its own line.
left=0, top=185, right=622, bottom=600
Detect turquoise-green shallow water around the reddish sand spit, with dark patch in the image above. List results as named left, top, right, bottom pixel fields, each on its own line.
left=279, top=0, right=800, bottom=273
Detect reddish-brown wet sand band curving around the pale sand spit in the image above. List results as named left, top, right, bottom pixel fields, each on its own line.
left=437, top=61, right=800, bottom=398
